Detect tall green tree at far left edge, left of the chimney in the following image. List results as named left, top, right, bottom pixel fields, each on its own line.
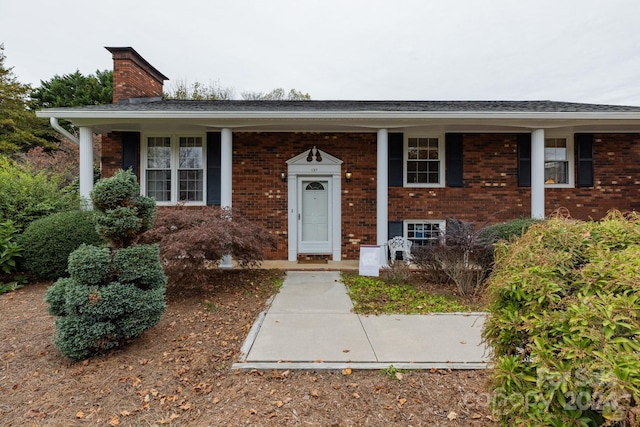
left=0, top=44, right=57, bottom=154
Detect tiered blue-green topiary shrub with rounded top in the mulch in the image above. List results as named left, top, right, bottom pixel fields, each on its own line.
left=45, top=172, right=167, bottom=360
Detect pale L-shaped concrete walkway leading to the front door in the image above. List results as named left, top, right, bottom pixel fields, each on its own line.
left=233, top=271, right=489, bottom=369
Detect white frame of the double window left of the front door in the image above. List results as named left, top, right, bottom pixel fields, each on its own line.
left=140, top=133, right=207, bottom=206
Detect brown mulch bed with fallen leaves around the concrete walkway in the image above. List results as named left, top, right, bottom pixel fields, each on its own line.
left=0, top=270, right=496, bottom=426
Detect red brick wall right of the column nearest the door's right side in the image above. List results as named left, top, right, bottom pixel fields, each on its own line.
left=389, top=134, right=640, bottom=227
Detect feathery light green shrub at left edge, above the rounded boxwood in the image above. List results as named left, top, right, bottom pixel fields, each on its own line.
left=0, top=156, right=80, bottom=230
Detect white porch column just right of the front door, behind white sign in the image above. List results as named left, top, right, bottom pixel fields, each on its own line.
left=376, top=129, right=389, bottom=265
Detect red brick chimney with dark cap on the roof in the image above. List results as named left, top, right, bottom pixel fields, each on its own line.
left=105, top=47, right=169, bottom=104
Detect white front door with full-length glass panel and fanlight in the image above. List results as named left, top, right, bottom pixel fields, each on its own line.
left=298, top=177, right=332, bottom=253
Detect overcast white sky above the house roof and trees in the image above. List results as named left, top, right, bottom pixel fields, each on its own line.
left=0, top=0, right=640, bottom=105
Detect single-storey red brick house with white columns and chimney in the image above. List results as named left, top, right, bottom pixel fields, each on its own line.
left=38, top=48, right=640, bottom=261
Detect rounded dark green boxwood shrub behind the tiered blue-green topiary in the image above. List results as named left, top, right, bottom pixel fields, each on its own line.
left=19, top=211, right=104, bottom=280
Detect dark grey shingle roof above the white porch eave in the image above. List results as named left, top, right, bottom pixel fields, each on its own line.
left=46, top=99, right=640, bottom=113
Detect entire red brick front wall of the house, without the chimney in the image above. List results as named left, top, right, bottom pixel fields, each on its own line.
left=103, top=133, right=640, bottom=259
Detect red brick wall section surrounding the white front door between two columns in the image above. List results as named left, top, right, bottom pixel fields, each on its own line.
left=233, top=133, right=377, bottom=259
